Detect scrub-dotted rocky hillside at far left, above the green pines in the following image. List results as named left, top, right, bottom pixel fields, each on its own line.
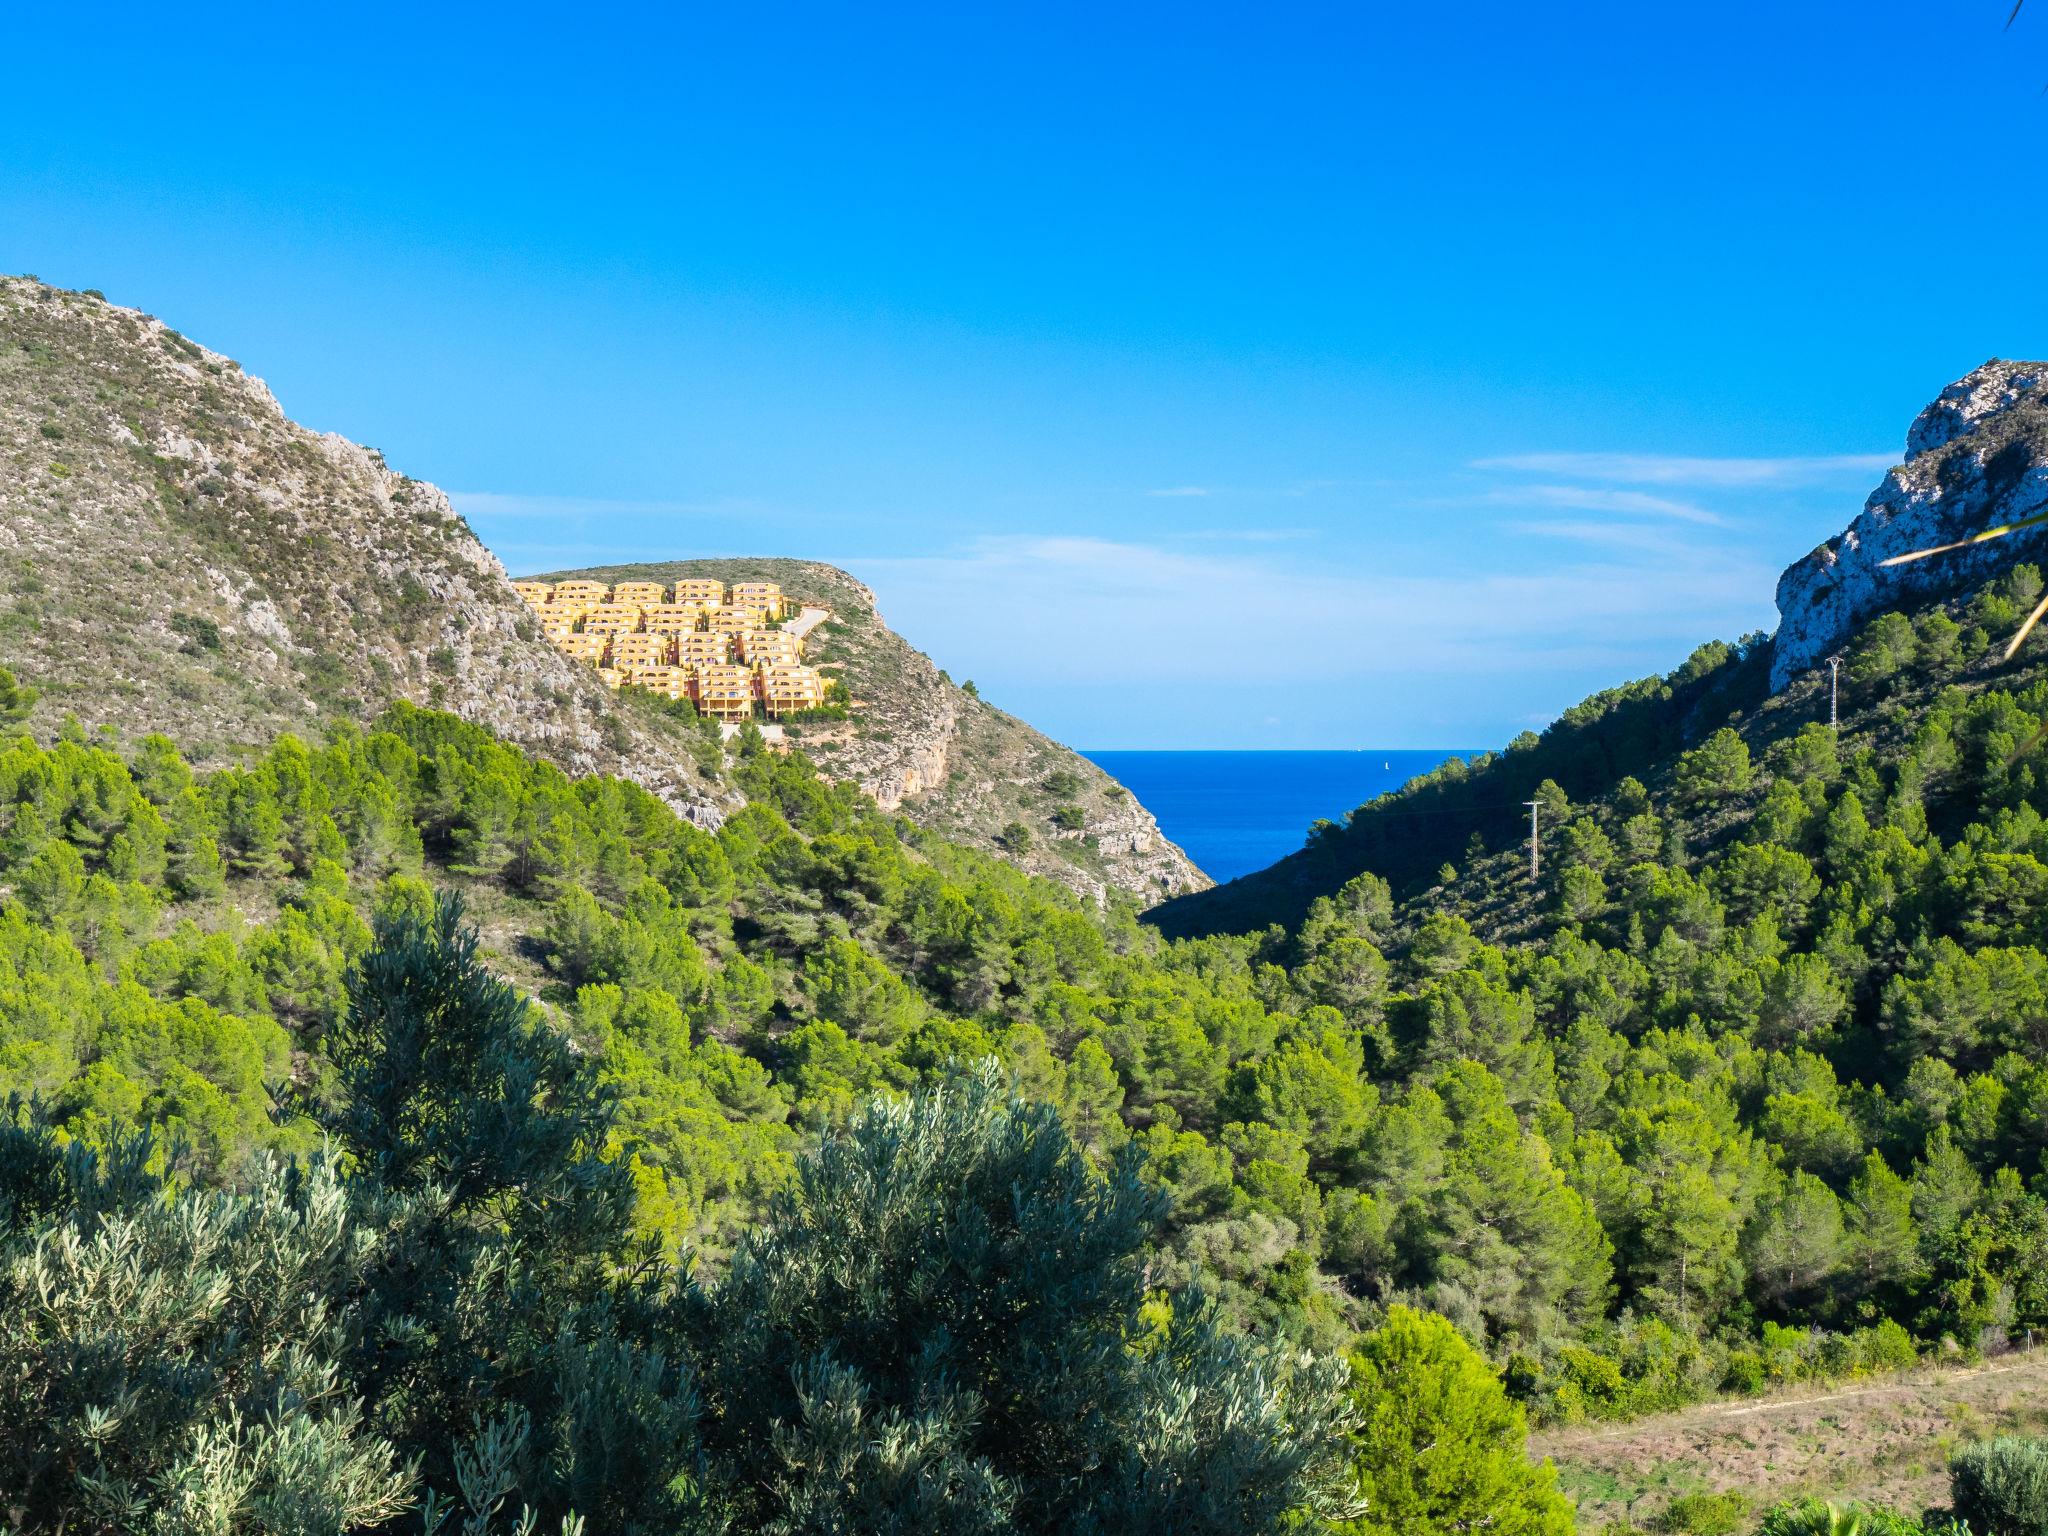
left=0, top=279, right=739, bottom=823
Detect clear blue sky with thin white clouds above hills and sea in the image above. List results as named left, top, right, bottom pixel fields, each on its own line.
left=0, top=0, right=2048, bottom=748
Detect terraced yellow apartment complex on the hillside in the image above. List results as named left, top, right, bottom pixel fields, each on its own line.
left=512, top=580, right=829, bottom=725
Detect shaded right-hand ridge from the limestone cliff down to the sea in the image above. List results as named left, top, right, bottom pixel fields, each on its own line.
left=1151, top=360, right=2048, bottom=934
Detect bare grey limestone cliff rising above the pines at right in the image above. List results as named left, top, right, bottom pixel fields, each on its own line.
left=1772, top=360, right=2048, bottom=688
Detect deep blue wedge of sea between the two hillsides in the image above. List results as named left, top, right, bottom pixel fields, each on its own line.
left=1081, top=748, right=1477, bottom=885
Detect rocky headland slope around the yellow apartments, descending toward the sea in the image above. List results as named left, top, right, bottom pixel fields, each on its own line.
left=535, top=559, right=1208, bottom=899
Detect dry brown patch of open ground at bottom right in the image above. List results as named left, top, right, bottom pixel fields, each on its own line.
left=1530, top=1350, right=2048, bottom=1532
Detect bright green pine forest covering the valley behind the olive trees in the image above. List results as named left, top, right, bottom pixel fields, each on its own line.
left=0, top=567, right=2048, bottom=1530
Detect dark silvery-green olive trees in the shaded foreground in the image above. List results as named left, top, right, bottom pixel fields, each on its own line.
left=0, top=899, right=1368, bottom=1536
